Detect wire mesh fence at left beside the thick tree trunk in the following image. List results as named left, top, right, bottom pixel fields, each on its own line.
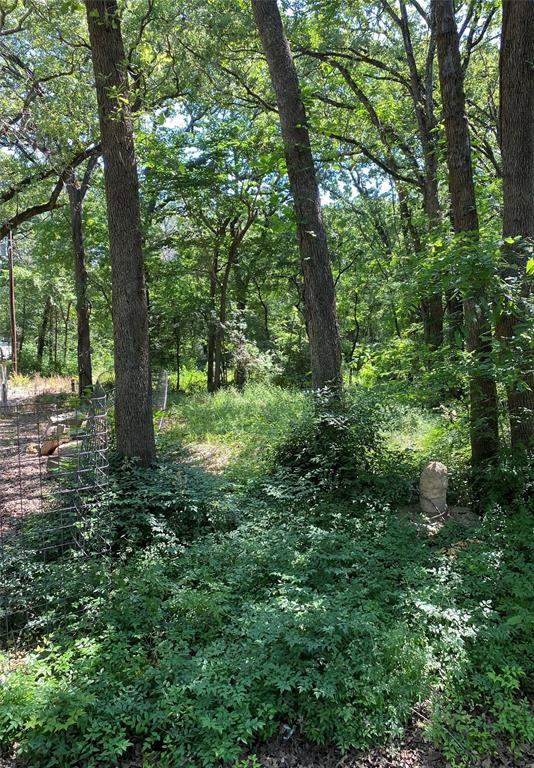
left=0, top=394, right=109, bottom=646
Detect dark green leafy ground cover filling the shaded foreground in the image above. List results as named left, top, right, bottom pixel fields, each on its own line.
left=0, top=390, right=534, bottom=766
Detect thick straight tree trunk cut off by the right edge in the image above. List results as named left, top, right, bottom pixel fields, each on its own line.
left=498, top=0, right=534, bottom=450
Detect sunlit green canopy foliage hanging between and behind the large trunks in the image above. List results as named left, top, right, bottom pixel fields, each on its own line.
left=0, top=0, right=532, bottom=416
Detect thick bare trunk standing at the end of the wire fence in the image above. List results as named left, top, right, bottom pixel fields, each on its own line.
left=85, top=0, right=156, bottom=465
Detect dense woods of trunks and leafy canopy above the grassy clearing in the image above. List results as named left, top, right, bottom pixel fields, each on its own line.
left=1, top=1, right=532, bottom=456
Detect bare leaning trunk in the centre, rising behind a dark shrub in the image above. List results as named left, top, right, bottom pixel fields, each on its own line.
left=252, top=0, right=341, bottom=388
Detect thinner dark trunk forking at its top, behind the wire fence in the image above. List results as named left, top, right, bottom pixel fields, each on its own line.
left=67, top=155, right=97, bottom=396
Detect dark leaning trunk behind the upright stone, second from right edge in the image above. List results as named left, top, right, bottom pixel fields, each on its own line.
left=432, top=0, right=499, bottom=467
